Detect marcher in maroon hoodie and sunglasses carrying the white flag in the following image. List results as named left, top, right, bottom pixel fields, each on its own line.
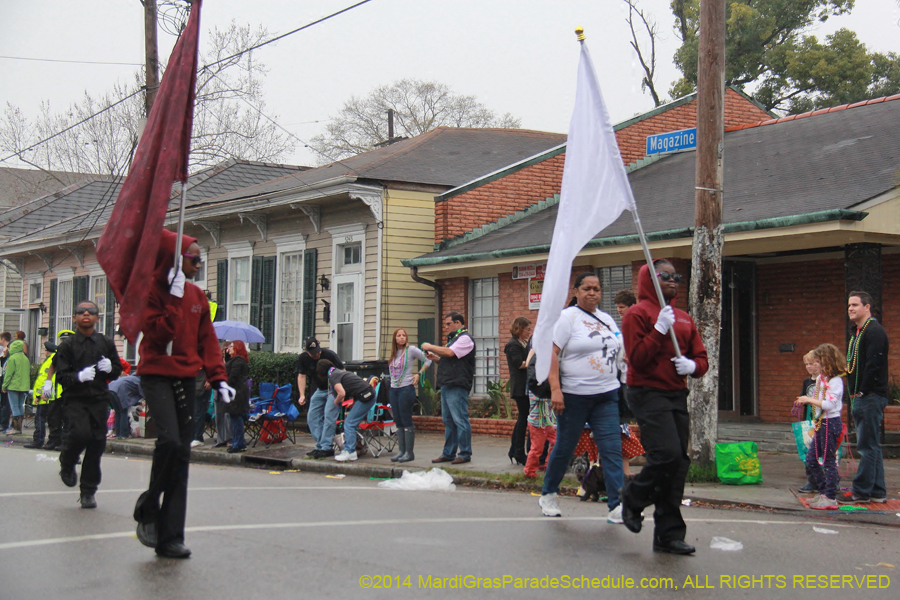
left=619, top=260, right=709, bottom=554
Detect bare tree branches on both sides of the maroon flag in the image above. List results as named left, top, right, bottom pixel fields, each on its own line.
left=0, top=22, right=294, bottom=175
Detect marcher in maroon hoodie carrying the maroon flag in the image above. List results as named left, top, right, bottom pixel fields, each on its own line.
left=134, top=230, right=234, bottom=558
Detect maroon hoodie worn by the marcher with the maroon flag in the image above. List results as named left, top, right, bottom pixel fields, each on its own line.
left=138, top=229, right=228, bottom=388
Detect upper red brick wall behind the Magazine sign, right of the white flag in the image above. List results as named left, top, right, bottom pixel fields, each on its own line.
left=616, top=88, right=772, bottom=165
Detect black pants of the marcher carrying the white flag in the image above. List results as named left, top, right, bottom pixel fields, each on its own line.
left=624, top=387, right=691, bottom=543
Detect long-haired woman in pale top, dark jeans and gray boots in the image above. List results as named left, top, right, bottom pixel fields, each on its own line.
left=388, top=329, right=431, bottom=462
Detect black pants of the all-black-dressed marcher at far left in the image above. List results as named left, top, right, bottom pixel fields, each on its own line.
left=59, top=395, right=109, bottom=494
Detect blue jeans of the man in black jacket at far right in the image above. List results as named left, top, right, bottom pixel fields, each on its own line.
left=853, top=394, right=887, bottom=498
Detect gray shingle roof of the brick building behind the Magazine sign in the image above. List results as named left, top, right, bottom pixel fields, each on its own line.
left=410, top=97, right=900, bottom=264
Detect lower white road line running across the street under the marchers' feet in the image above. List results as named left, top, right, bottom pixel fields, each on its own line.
left=0, top=516, right=884, bottom=551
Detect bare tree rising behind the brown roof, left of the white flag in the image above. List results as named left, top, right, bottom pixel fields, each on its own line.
left=309, top=79, right=521, bottom=163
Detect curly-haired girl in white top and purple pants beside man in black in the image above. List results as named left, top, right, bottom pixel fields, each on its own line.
left=795, top=344, right=847, bottom=510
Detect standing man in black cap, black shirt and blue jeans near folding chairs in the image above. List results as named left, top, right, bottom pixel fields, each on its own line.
left=297, top=337, right=344, bottom=458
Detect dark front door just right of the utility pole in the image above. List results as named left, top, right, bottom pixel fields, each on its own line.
left=719, top=261, right=757, bottom=420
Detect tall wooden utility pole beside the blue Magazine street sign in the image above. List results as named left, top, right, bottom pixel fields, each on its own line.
left=689, top=0, right=725, bottom=465
